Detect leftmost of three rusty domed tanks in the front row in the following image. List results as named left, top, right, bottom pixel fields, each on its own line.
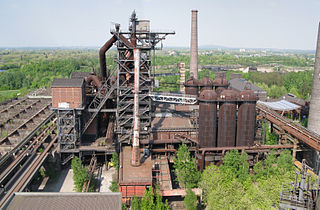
left=198, top=90, right=217, bottom=148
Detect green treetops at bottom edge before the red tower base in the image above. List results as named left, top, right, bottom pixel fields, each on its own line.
left=131, top=188, right=170, bottom=210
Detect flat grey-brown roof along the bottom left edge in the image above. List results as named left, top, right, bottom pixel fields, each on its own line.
left=4, top=192, right=122, bottom=210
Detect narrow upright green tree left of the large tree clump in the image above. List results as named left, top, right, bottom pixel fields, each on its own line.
left=173, top=142, right=201, bottom=188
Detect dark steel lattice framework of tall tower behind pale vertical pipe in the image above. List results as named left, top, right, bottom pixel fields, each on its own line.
left=111, top=13, right=174, bottom=143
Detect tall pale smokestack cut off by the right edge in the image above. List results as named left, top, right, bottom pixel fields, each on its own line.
left=308, top=23, right=320, bottom=135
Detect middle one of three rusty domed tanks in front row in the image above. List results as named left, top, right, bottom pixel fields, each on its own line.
left=217, top=90, right=239, bottom=147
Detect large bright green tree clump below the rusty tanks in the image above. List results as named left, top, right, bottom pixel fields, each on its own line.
left=200, top=151, right=295, bottom=209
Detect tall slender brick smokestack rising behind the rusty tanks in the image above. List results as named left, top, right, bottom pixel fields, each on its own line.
left=190, top=10, right=198, bottom=79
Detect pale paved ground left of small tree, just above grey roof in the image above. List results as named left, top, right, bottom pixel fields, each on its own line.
left=43, top=168, right=75, bottom=192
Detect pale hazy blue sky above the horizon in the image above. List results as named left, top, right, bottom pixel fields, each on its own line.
left=0, top=0, right=320, bottom=50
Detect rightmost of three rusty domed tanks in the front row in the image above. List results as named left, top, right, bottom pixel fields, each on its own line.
left=236, top=90, right=257, bottom=146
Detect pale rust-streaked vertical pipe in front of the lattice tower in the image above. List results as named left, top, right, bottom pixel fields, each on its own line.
left=131, top=48, right=140, bottom=166
